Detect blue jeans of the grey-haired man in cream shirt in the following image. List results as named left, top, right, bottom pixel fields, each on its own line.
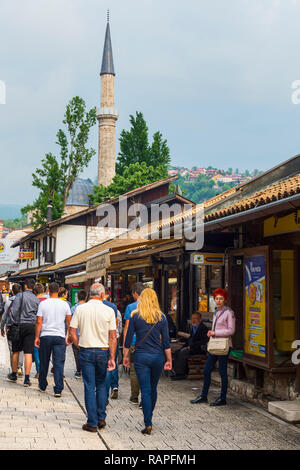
left=80, top=348, right=109, bottom=427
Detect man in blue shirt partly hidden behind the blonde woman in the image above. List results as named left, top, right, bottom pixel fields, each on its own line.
left=123, top=282, right=145, bottom=405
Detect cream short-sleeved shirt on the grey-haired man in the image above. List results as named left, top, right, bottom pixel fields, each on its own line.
left=70, top=299, right=116, bottom=348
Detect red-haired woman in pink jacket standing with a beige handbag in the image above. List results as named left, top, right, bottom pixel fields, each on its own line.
left=191, top=289, right=235, bottom=406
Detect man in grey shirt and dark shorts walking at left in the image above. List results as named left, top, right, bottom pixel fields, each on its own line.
left=7, top=279, right=40, bottom=387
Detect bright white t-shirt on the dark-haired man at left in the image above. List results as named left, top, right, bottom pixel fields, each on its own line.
left=37, top=298, right=71, bottom=338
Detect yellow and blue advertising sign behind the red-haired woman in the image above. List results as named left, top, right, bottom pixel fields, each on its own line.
left=245, top=256, right=266, bottom=358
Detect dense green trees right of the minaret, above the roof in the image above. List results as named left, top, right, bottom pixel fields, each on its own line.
left=90, top=112, right=170, bottom=204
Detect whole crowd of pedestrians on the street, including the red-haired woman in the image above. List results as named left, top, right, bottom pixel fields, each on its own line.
left=0, top=279, right=235, bottom=435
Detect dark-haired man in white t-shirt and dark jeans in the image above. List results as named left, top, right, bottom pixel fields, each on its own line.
left=34, top=282, right=71, bottom=397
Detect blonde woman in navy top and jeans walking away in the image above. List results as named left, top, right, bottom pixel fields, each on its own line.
left=123, top=288, right=172, bottom=434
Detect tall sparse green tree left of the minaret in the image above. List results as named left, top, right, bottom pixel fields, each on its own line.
left=22, top=96, right=96, bottom=228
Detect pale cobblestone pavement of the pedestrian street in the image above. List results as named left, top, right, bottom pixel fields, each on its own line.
left=0, top=338, right=300, bottom=450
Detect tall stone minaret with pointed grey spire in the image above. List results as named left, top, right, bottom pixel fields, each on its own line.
left=97, top=11, right=118, bottom=186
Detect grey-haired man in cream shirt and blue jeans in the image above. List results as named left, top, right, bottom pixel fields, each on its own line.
left=70, top=283, right=117, bottom=432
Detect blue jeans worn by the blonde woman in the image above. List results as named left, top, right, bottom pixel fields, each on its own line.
left=134, top=352, right=165, bottom=426
